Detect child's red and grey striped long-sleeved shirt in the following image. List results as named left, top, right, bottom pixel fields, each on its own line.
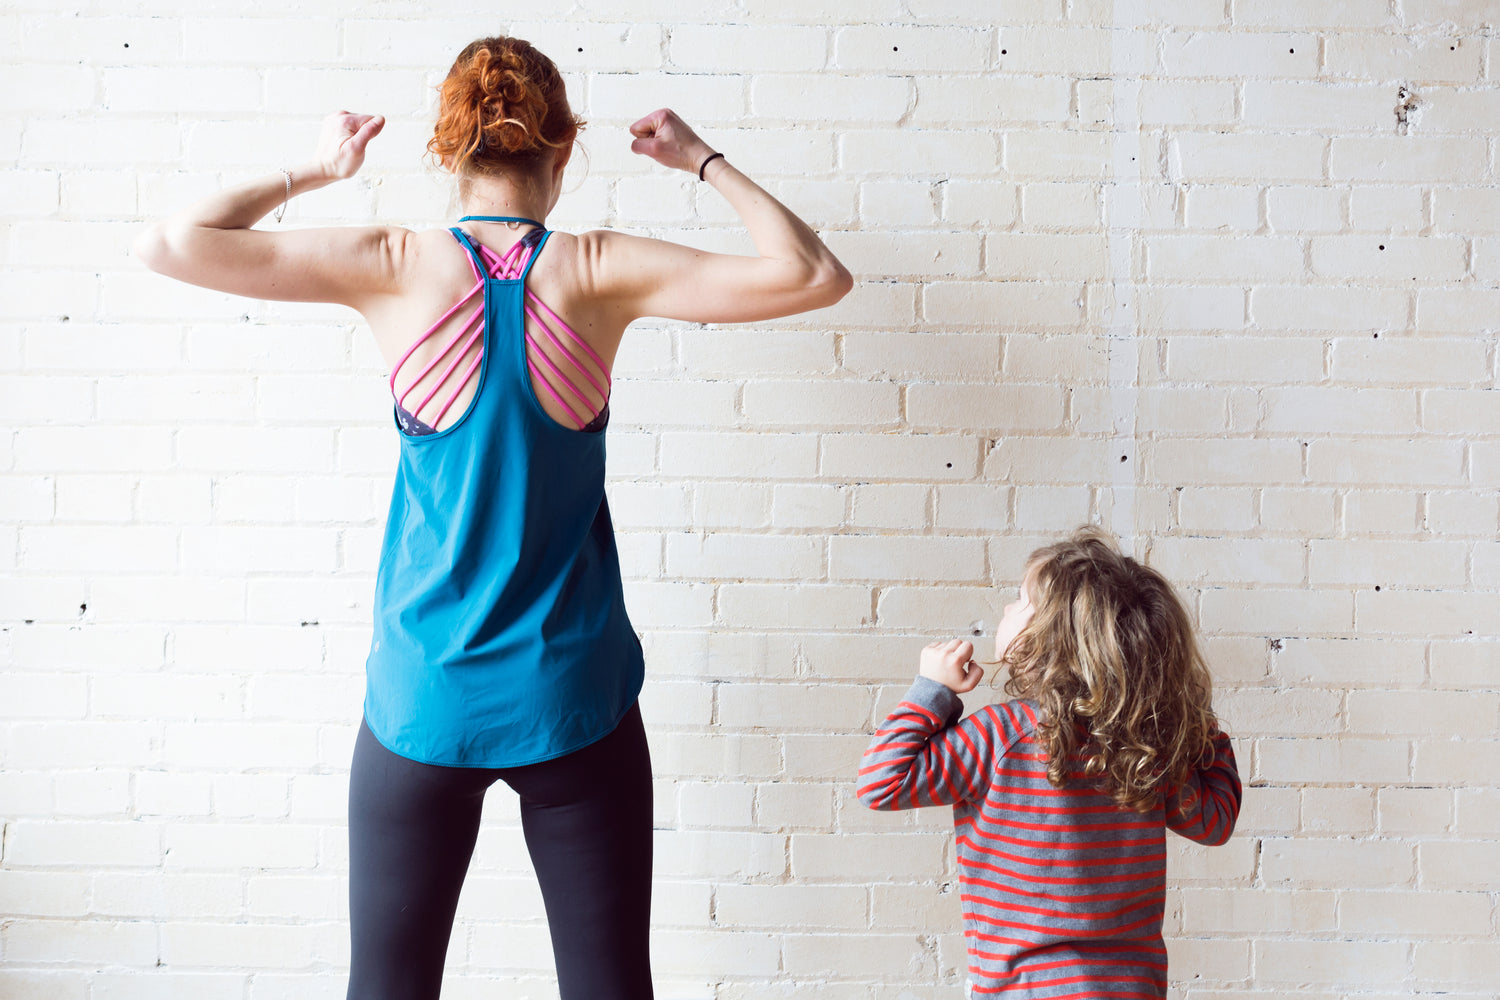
left=860, top=678, right=1241, bottom=1000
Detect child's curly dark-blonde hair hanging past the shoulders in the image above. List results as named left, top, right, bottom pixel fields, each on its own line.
left=1001, top=526, right=1218, bottom=813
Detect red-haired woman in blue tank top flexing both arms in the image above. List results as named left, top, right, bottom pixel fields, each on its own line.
left=135, top=37, right=851, bottom=1000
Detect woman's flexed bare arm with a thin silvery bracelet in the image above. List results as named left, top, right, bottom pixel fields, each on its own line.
left=132, top=111, right=411, bottom=309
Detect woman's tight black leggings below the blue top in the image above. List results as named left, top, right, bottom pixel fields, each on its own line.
left=348, top=706, right=651, bottom=1000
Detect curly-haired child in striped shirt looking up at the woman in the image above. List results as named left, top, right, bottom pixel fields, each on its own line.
left=860, top=528, right=1241, bottom=1000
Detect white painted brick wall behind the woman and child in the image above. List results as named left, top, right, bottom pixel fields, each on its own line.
left=0, top=0, right=1500, bottom=1000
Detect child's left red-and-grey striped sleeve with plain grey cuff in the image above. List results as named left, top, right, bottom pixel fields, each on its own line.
left=860, top=678, right=998, bottom=810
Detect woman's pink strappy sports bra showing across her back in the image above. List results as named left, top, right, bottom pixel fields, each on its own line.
left=390, top=216, right=611, bottom=436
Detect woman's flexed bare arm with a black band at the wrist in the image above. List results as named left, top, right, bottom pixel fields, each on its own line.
left=579, top=108, right=854, bottom=322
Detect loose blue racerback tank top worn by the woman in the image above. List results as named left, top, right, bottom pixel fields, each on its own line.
left=365, top=218, right=645, bottom=768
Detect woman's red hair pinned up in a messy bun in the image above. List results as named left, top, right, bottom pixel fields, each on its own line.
left=428, top=34, right=584, bottom=174
